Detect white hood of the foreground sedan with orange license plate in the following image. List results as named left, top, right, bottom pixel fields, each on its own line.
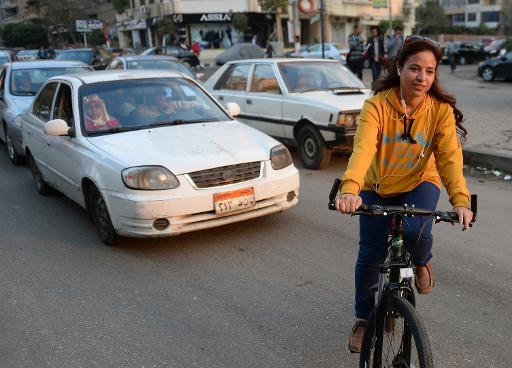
left=87, top=121, right=279, bottom=175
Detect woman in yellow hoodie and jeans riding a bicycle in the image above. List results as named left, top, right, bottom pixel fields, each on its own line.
left=336, top=36, right=473, bottom=352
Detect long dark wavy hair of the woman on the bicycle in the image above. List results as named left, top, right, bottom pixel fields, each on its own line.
left=372, top=39, right=467, bottom=139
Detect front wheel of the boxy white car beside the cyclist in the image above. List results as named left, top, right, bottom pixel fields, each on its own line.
left=297, top=125, right=331, bottom=170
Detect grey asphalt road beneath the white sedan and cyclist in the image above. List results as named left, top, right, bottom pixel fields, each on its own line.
left=0, top=145, right=512, bottom=368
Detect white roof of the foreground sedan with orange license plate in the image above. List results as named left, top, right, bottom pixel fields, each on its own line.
left=50, top=69, right=183, bottom=84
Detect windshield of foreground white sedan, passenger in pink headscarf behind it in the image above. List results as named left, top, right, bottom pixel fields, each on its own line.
left=80, top=78, right=231, bottom=135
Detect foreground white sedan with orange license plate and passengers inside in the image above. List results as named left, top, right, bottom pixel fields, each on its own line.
left=22, top=70, right=299, bottom=244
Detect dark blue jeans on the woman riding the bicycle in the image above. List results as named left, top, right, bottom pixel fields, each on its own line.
left=355, top=182, right=440, bottom=319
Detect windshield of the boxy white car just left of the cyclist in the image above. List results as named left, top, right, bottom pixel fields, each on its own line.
left=279, top=61, right=365, bottom=93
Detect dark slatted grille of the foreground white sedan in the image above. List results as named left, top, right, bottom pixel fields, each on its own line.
left=188, top=161, right=261, bottom=188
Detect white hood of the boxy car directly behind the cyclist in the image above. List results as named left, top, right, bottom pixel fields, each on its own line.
left=294, top=89, right=370, bottom=111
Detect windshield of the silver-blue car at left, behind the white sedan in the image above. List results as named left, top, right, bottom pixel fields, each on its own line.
left=10, top=66, right=90, bottom=96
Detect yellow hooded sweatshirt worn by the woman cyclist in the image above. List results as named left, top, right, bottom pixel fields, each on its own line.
left=340, top=88, right=470, bottom=208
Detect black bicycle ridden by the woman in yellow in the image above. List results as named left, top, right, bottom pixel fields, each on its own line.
left=329, top=179, right=477, bottom=368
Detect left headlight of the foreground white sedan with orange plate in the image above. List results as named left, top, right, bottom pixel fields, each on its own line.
left=121, top=166, right=180, bottom=190
